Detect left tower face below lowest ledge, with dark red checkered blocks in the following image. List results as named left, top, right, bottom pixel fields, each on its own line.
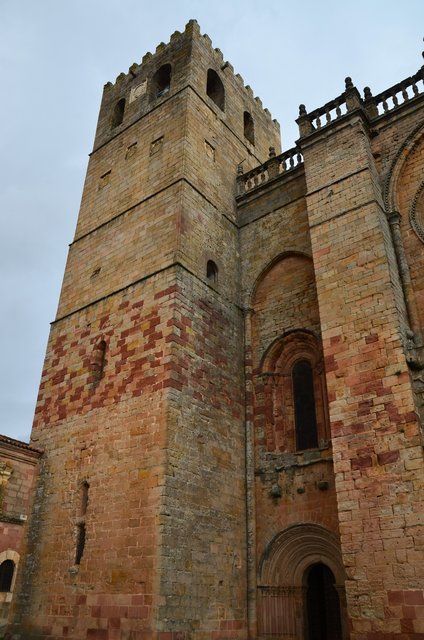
left=17, top=272, right=175, bottom=638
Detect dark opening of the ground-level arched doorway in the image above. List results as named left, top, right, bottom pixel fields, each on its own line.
left=306, top=564, right=343, bottom=640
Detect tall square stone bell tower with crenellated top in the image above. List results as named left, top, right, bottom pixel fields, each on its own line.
left=15, top=21, right=279, bottom=640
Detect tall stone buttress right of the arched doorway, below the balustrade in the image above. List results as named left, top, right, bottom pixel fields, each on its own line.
left=302, top=107, right=422, bottom=639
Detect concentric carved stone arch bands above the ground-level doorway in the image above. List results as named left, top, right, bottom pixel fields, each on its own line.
left=258, top=524, right=346, bottom=587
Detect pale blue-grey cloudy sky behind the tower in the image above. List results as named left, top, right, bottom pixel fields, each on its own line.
left=0, top=0, right=424, bottom=441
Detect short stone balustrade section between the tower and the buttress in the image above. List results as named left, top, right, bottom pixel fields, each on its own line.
left=237, top=147, right=303, bottom=195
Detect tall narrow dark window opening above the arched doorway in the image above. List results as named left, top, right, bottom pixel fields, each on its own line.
left=292, top=360, right=318, bottom=451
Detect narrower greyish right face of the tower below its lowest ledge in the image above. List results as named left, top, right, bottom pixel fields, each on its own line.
left=158, top=269, right=246, bottom=638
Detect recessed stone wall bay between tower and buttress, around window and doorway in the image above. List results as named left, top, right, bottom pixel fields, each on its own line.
left=239, top=167, right=338, bottom=638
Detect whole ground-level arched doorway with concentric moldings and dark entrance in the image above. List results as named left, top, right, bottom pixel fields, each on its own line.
left=257, top=524, right=349, bottom=640
